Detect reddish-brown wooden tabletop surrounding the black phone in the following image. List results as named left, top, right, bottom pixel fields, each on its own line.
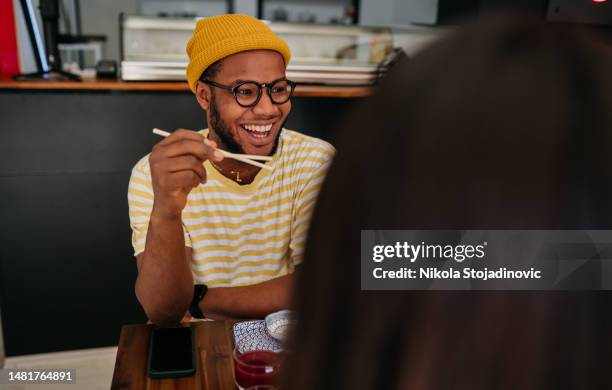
left=111, top=321, right=235, bottom=390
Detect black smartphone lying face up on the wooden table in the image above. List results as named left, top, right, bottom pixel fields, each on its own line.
left=149, top=327, right=196, bottom=378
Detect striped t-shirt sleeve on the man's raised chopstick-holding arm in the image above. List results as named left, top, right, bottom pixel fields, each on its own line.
left=128, top=155, right=191, bottom=256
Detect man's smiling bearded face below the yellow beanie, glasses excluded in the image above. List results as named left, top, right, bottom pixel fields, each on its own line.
left=196, top=50, right=291, bottom=155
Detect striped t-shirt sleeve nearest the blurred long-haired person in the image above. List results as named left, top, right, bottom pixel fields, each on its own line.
left=289, top=141, right=335, bottom=268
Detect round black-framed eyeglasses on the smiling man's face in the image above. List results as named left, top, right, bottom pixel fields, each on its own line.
left=201, top=78, right=295, bottom=108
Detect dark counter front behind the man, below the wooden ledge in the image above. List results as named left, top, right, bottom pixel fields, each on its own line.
left=0, top=91, right=354, bottom=356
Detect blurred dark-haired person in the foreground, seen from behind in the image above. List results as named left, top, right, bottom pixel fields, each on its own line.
left=285, top=12, right=612, bottom=390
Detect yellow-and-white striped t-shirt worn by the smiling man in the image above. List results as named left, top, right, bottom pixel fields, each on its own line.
left=128, top=129, right=335, bottom=287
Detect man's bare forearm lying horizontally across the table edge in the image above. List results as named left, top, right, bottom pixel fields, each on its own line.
left=200, top=273, right=295, bottom=319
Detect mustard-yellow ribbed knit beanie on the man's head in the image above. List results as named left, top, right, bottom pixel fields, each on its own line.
left=187, top=14, right=291, bottom=93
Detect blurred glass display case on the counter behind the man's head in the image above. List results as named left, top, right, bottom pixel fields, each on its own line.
left=121, top=16, right=396, bottom=85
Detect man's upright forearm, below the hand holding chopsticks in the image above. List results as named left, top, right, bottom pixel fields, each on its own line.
left=136, top=213, right=193, bottom=323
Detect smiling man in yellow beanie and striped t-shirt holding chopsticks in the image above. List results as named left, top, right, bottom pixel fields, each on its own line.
left=128, top=15, right=334, bottom=323
